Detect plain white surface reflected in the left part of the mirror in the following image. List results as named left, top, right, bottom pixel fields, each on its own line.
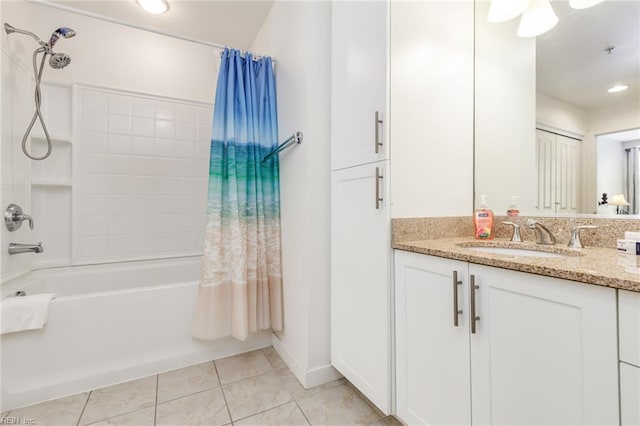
left=475, top=2, right=537, bottom=214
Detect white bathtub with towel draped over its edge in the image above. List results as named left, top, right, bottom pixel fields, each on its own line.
left=0, top=257, right=271, bottom=412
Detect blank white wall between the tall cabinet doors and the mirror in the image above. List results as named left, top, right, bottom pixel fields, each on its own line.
left=389, top=1, right=474, bottom=218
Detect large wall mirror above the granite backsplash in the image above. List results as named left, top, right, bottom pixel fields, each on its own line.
left=474, top=0, right=640, bottom=215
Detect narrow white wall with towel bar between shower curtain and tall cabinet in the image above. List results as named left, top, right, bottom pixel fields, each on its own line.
left=252, top=1, right=335, bottom=386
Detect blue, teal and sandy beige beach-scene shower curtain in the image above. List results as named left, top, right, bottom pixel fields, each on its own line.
left=192, top=49, right=283, bottom=340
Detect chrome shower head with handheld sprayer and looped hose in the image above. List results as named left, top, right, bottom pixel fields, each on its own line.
left=4, top=22, right=76, bottom=160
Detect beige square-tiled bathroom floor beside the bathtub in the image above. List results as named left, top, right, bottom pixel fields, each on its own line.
left=0, top=348, right=400, bottom=426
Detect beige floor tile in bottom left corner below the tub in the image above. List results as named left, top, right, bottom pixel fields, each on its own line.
left=7, top=392, right=89, bottom=426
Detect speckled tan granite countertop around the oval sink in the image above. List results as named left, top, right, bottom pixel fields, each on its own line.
left=393, top=237, right=640, bottom=292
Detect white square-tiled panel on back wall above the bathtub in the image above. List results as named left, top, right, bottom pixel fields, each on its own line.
left=73, top=86, right=212, bottom=263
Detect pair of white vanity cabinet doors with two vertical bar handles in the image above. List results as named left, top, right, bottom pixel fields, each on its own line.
left=395, top=251, right=619, bottom=425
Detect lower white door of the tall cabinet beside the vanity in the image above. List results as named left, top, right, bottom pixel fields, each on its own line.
left=331, top=161, right=392, bottom=414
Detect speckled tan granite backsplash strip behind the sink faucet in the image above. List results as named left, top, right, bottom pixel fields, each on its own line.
left=391, top=216, right=640, bottom=248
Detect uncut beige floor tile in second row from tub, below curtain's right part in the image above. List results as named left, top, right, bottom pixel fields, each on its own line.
left=222, top=371, right=292, bottom=421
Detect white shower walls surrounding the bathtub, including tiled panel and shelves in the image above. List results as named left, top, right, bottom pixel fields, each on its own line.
left=1, top=1, right=220, bottom=277
